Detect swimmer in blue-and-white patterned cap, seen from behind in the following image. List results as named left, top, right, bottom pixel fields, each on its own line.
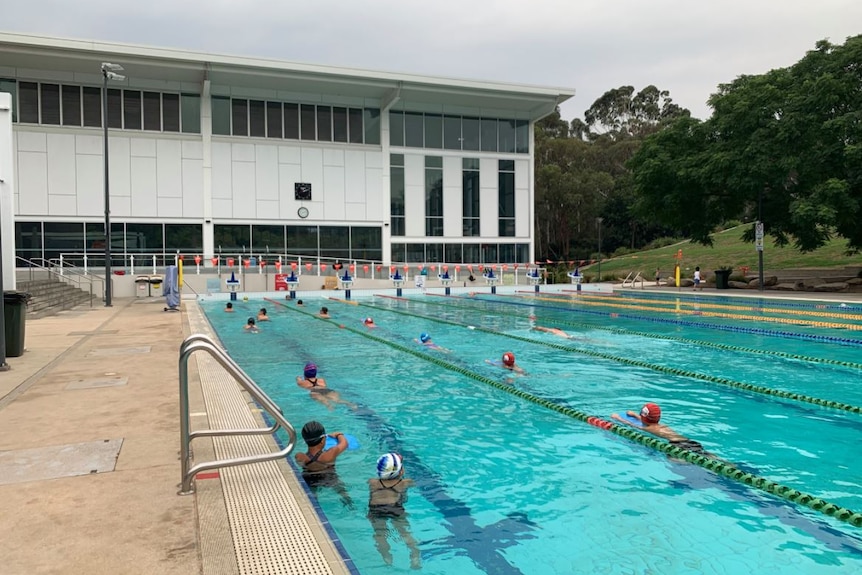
left=367, top=453, right=422, bottom=569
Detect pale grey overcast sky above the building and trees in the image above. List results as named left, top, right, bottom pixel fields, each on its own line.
left=0, top=0, right=862, bottom=120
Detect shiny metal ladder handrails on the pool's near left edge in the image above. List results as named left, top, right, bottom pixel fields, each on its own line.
left=179, top=334, right=296, bottom=495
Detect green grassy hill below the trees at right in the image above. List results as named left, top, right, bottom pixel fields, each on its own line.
left=582, top=226, right=862, bottom=279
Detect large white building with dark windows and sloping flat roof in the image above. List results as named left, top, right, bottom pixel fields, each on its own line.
left=0, top=34, right=573, bottom=282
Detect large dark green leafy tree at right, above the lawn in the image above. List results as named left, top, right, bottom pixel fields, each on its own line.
left=628, top=36, right=862, bottom=251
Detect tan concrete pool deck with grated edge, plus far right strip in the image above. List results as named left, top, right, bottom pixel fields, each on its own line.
left=0, top=286, right=862, bottom=575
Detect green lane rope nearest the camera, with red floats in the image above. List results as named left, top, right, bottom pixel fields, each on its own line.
left=278, top=300, right=862, bottom=527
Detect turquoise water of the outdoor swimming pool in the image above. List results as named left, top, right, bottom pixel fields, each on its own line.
left=204, top=296, right=862, bottom=574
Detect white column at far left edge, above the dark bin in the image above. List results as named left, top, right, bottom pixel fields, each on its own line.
left=0, top=92, right=16, bottom=290
